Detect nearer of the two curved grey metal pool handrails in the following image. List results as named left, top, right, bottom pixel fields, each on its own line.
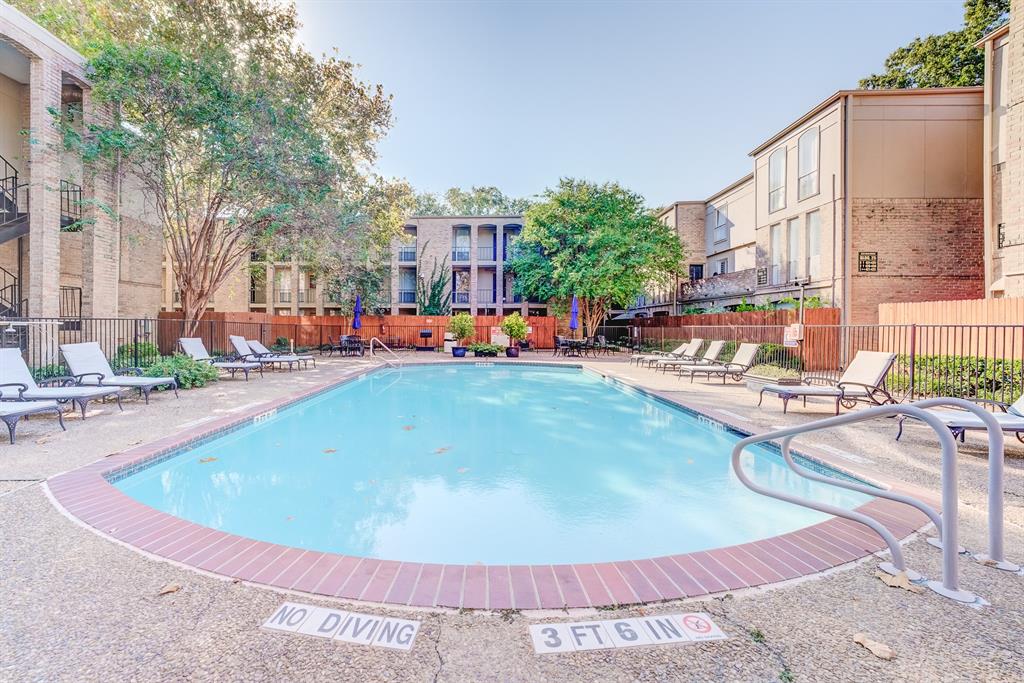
left=732, top=404, right=977, bottom=602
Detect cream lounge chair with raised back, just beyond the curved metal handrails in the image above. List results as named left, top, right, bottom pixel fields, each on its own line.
left=758, top=351, right=898, bottom=415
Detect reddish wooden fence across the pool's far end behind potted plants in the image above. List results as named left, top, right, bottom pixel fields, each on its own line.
left=159, top=311, right=556, bottom=352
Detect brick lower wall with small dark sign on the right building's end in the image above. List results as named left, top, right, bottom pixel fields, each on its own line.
left=849, top=198, right=984, bottom=325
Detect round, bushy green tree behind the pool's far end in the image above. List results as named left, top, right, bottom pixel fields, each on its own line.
left=506, top=178, right=683, bottom=334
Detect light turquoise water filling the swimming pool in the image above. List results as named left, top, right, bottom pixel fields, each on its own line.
left=116, top=361, right=868, bottom=564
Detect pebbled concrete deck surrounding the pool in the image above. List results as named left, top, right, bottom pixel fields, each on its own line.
left=0, top=352, right=1024, bottom=680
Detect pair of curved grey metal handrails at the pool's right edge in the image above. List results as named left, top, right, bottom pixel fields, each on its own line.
left=732, top=398, right=1020, bottom=603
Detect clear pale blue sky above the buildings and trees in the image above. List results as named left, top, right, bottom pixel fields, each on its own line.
left=299, top=0, right=963, bottom=206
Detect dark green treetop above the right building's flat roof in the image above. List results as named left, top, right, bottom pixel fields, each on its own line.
left=860, top=0, right=1011, bottom=89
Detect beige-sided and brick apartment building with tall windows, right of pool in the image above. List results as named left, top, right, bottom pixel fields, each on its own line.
left=638, top=87, right=985, bottom=324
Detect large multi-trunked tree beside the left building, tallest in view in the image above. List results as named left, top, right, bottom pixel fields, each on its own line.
left=38, top=0, right=395, bottom=331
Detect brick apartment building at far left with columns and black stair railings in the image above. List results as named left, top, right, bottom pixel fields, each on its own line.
left=0, top=3, right=163, bottom=317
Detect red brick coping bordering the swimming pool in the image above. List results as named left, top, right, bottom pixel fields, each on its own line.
left=46, top=361, right=933, bottom=609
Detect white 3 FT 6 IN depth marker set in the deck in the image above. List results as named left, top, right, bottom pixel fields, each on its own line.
left=529, top=612, right=728, bottom=654
